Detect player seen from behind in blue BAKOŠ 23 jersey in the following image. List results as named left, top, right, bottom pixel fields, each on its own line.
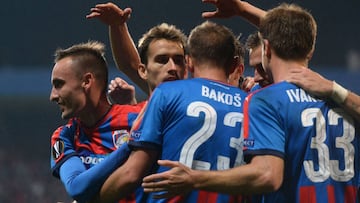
left=93, top=22, right=246, bottom=202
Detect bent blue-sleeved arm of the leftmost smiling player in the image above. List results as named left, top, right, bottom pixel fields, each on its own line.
left=60, top=144, right=130, bottom=202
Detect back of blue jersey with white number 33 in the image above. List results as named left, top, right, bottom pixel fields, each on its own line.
left=246, top=82, right=360, bottom=202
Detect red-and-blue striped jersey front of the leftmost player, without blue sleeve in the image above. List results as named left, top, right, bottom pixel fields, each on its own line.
left=51, top=102, right=145, bottom=202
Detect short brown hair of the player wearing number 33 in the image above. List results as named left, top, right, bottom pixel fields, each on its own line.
left=259, top=3, right=317, bottom=60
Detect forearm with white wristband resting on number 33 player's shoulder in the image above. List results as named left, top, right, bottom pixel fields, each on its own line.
left=287, top=68, right=360, bottom=122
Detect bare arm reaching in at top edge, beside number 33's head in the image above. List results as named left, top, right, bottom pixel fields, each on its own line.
left=202, top=0, right=266, bottom=27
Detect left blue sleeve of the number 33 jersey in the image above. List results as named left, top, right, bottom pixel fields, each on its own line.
left=243, top=94, right=285, bottom=161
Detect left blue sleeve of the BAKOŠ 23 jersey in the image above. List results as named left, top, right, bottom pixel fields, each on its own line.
left=129, top=88, right=166, bottom=150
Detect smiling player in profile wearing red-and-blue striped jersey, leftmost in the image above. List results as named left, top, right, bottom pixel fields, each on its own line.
left=50, top=41, right=144, bottom=202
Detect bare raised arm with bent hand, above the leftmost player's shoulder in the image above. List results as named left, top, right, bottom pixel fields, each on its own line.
left=86, top=3, right=148, bottom=92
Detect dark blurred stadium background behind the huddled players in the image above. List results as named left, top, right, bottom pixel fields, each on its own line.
left=0, top=0, right=360, bottom=203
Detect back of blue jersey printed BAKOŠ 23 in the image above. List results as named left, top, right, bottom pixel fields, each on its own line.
left=131, top=78, right=246, bottom=202
